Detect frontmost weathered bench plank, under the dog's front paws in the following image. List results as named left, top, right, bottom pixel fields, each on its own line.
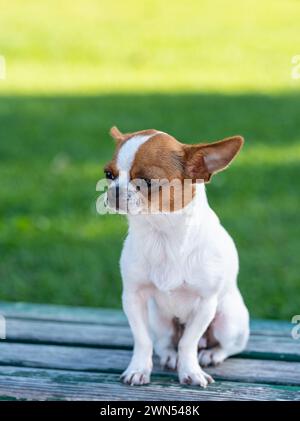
left=0, top=367, right=300, bottom=400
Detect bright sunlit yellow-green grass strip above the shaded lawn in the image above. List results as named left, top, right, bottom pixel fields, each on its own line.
left=0, top=0, right=300, bottom=94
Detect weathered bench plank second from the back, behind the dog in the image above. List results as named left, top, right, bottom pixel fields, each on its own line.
left=6, top=319, right=300, bottom=361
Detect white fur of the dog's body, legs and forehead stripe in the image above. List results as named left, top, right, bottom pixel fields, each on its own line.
left=119, top=171, right=249, bottom=387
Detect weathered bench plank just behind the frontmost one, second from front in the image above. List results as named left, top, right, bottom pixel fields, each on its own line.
left=0, top=342, right=300, bottom=385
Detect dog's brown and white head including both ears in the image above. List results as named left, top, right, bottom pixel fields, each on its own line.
left=104, top=127, right=244, bottom=214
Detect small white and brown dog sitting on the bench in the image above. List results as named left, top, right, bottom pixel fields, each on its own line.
left=105, top=127, right=249, bottom=387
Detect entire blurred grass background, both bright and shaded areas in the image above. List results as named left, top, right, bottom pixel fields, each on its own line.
left=0, top=0, right=300, bottom=320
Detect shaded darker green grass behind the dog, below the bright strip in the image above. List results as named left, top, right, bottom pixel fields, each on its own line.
left=0, top=90, right=300, bottom=320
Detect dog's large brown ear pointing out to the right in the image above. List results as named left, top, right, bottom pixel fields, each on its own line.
left=185, top=136, right=244, bottom=182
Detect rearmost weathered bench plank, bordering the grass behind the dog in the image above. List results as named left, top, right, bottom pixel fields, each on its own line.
left=0, top=301, right=293, bottom=336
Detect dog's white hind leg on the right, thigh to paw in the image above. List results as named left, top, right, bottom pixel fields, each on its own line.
left=199, top=290, right=249, bottom=367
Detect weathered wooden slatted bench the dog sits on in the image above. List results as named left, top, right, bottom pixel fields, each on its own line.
left=0, top=303, right=300, bottom=401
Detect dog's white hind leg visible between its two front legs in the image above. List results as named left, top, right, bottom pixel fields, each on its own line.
left=148, top=300, right=178, bottom=370
